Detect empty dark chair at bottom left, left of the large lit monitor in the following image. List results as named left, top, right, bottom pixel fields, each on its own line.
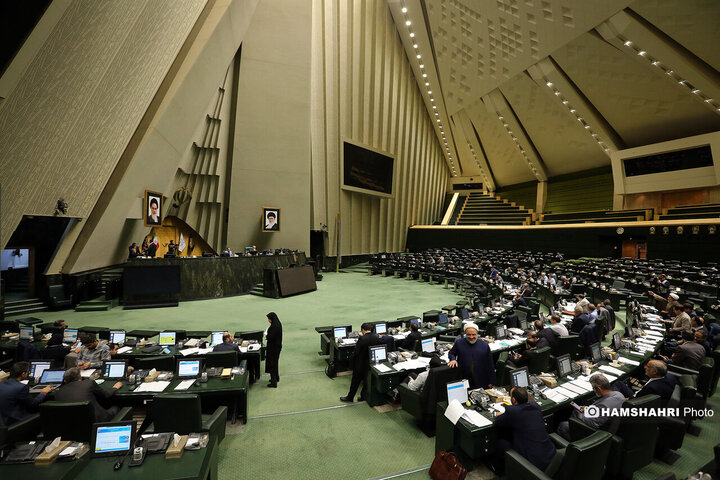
left=40, top=401, right=132, bottom=442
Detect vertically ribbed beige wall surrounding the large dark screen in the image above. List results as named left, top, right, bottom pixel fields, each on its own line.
left=312, top=0, right=448, bottom=255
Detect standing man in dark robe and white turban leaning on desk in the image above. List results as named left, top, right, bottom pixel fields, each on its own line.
left=448, top=323, right=495, bottom=389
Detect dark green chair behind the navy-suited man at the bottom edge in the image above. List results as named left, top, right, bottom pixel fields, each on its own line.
left=505, top=431, right=612, bottom=480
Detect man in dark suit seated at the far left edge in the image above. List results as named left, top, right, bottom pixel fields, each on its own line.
left=0, top=362, right=52, bottom=426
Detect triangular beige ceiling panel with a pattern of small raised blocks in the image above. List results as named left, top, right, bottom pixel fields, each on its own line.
left=426, top=0, right=630, bottom=114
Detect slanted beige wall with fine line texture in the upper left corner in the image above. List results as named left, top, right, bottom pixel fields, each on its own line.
left=0, top=0, right=205, bottom=253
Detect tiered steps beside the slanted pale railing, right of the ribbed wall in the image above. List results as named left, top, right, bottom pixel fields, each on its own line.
left=451, top=192, right=533, bottom=225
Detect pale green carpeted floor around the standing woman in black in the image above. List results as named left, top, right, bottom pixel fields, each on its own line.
left=25, top=273, right=720, bottom=480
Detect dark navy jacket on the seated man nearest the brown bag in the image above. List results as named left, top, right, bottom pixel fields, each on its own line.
left=495, top=402, right=555, bottom=470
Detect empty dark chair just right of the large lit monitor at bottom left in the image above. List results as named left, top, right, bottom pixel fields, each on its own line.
left=147, top=393, right=227, bottom=442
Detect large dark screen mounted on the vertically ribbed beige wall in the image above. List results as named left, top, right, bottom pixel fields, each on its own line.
left=343, top=142, right=395, bottom=195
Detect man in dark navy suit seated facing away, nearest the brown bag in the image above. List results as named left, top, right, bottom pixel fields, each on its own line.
left=493, top=387, right=555, bottom=473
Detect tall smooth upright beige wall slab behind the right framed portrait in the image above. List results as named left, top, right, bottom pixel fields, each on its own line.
left=227, top=0, right=311, bottom=252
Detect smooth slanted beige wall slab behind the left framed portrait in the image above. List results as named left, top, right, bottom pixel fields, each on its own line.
left=67, top=0, right=259, bottom=273
